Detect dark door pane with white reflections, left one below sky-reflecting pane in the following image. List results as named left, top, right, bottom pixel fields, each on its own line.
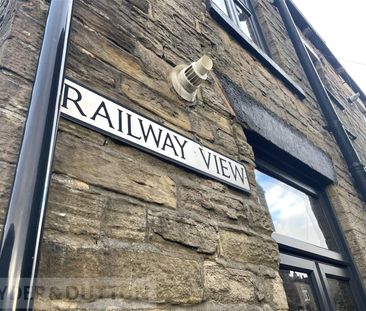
left=280, top=269, right=319, bottom=311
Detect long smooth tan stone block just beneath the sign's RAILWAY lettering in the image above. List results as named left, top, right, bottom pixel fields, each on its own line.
left=55, top=132, right=176, bottom=208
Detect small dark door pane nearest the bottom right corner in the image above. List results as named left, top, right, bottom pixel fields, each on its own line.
left=327, top=278, right=357, bottom=311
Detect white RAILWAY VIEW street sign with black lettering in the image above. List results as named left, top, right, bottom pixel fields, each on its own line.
left=61, top=78, right=250, bottom=192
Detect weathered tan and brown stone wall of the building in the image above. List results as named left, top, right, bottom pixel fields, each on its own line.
left=0, top=0, right=366, bottom=311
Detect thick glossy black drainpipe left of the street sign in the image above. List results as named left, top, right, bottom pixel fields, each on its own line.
left=0, top=0, right=73, bottom=310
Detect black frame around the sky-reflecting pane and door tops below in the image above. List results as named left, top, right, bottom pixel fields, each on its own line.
left=256, top=159, right=365, bottom=311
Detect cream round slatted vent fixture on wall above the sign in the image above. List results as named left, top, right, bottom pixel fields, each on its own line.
left=171, top=55, right=213, bottom=102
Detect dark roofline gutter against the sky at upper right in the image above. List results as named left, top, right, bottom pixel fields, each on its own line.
left=287, top=0, right=366, bottom=105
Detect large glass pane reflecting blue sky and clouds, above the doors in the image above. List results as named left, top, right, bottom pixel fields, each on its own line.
left=256, top=171, right=336, bottom=250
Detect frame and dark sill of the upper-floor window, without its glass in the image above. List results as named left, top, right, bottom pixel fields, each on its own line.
left=206, top=0, right=306, bottom=99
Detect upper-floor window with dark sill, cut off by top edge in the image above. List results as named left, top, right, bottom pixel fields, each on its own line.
left=206, top=0, right=305, bottom=99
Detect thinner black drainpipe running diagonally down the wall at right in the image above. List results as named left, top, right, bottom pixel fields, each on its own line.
left=275, top=0, right=366, bottom=202
